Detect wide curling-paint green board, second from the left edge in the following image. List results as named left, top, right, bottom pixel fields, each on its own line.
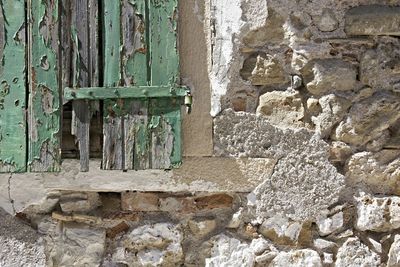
left=28, top=0, right=61, bottom=172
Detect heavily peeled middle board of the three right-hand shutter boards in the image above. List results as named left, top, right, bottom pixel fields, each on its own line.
left=121, top=0, right=151, bottom=170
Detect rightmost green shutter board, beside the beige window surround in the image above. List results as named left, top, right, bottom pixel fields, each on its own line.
left=149, top=0, right=182, bottom=169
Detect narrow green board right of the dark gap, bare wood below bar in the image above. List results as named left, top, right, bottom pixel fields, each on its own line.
left=102, top=0, right=125, bottom=170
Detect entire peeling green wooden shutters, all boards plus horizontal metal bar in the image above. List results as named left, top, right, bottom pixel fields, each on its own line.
left=0, top=0, right=188, bottom=172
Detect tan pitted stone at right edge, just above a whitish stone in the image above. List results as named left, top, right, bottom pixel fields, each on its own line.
left=345, top=149, right=400, bottom=194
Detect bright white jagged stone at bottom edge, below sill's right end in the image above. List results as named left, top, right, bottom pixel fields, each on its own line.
left=205, top=237, right=277, bottom=267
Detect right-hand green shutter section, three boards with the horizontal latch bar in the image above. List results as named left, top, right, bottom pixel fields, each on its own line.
left=64, top=0, right=187, bottom=170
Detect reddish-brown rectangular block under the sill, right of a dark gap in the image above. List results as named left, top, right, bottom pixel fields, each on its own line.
left=121, top=192, right=159, bottom=211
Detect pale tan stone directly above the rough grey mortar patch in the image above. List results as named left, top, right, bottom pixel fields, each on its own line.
left=257, top=91, right=304, bottom=127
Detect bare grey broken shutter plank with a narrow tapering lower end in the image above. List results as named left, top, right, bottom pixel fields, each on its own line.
left=71, top=0, right=92, bottom=172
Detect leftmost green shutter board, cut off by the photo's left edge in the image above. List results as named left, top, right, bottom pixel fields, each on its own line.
left=0, top=0, right=27, bottom=172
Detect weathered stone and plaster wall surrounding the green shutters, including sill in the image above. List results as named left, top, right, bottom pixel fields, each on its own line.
left=0, top=0, right=400, bottom=267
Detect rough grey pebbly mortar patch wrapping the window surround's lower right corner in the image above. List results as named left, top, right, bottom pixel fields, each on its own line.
left=214, top=110, right=344, bottom=224
